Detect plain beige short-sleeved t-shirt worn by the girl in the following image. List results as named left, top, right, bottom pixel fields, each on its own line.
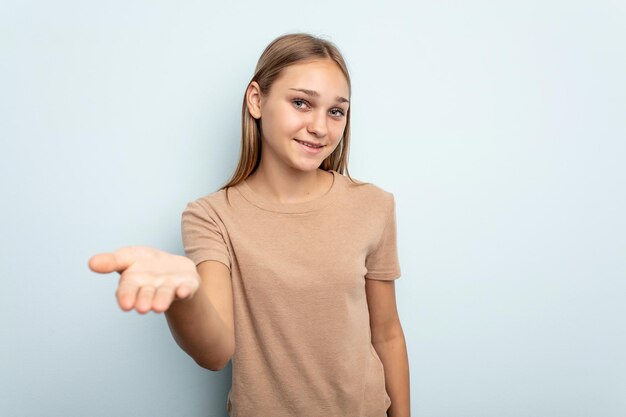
left=182, top=170, right=400, bottom=417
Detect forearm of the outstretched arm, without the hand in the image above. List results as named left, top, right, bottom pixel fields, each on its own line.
left=165, top=285, right=235, bottom=371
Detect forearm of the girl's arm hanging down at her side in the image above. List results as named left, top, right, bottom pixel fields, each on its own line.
left=372, top=328, right=411, bottom=417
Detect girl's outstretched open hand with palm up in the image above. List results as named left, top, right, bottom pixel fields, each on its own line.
left=89, top=246, right=200, bottom=314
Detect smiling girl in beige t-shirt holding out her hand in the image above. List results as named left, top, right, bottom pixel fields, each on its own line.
left=89, top=33, right=410, bottom=417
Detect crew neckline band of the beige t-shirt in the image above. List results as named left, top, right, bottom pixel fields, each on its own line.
left=237, top=169, right=341, bottom=213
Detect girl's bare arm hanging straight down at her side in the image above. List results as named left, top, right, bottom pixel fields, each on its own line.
left=365, top=279, right=411, bottom=417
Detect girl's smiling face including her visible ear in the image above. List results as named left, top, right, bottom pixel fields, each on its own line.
left=248, top=60, right=349, bottom=171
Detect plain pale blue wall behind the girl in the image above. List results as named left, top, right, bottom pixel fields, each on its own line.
left=0, top=0, right=626, bottom=417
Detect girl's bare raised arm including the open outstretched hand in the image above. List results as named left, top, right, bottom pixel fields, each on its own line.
left=89, top=246, right=235, bottom=371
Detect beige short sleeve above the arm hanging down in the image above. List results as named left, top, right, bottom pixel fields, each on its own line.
left=365, top=193, right=401, bottom=281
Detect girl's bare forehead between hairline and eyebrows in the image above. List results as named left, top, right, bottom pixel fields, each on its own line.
left=274, top=60, right=350, bottom=98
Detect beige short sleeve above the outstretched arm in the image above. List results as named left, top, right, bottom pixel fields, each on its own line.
left=181, top=200, right=231, bottom=269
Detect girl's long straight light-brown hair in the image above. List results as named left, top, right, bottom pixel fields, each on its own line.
left=220, top=33, right=363, bottom=195
